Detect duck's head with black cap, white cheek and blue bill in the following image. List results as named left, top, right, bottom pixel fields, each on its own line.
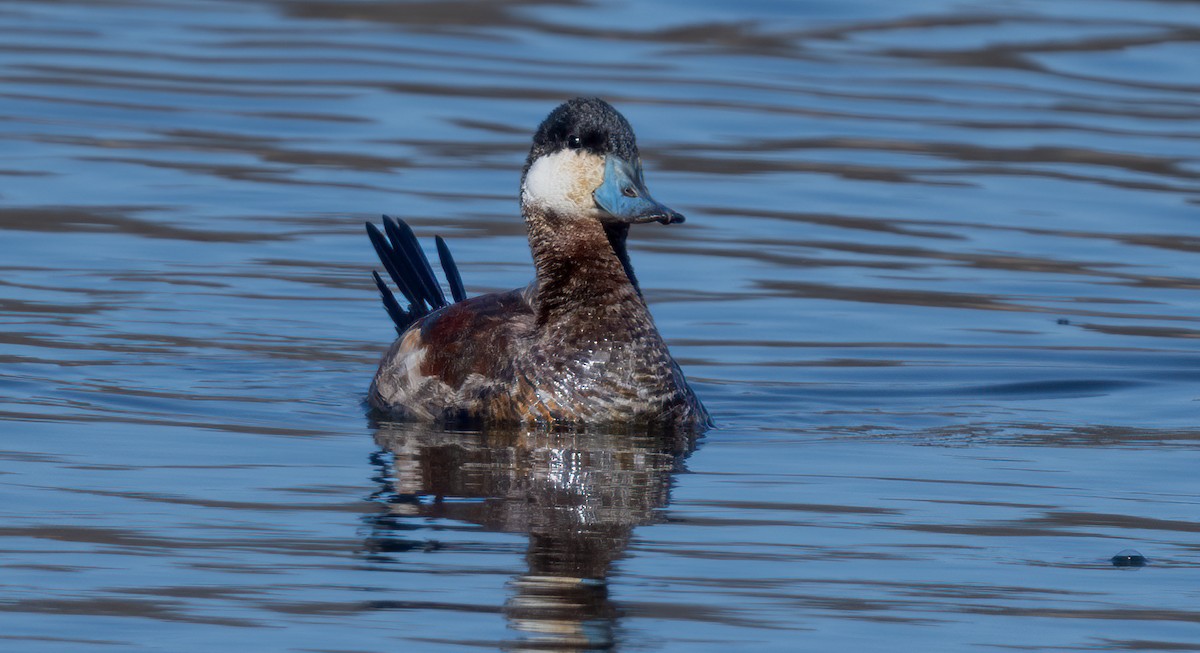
left=521, top=97, right=684, bottom=226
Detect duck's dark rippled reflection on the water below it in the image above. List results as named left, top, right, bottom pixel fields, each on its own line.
left=370, top=424, right=695, bottom=651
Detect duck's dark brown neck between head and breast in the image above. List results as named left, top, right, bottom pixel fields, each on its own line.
left=526, top=210, right=648, bottom=329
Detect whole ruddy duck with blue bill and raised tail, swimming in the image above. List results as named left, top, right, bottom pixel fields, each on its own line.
left=366, top=97, right=713, bottom=432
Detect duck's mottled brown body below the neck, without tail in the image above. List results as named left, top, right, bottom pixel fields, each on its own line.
left=370, top=284, right=708, bottom=426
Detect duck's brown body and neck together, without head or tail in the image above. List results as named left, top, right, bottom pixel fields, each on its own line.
left=371, top=216, right=709, bottom=429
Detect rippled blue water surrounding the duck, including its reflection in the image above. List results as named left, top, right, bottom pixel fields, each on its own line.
left=0, top=0, right=1200, bottom=652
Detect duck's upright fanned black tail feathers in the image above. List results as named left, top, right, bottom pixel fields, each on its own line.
left=367, top=216, right=467, bottom=334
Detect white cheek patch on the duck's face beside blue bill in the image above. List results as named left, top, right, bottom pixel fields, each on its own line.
left=521, top=150, right=604, bottom=216
